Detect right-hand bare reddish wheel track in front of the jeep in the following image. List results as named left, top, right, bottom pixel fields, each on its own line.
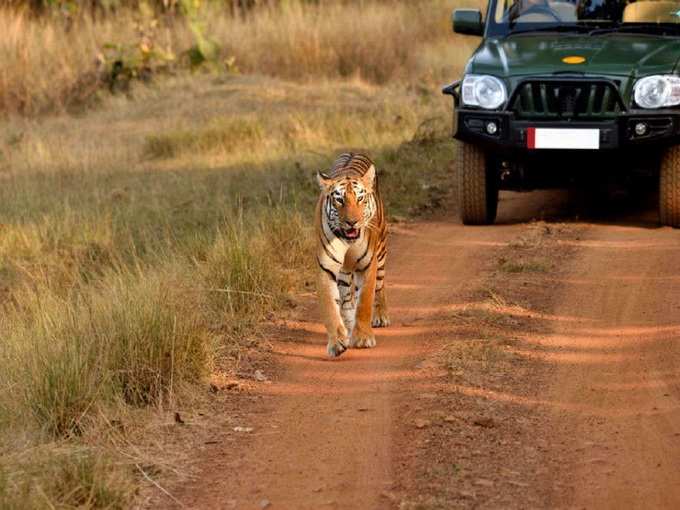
left=544, top=225, right=680, bottom=508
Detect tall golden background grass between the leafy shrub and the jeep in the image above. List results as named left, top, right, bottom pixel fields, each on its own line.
left=211, top=1, right=449, bottom=83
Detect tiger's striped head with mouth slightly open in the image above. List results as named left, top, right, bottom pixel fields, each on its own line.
left=317, top=165, right=375, bottom=242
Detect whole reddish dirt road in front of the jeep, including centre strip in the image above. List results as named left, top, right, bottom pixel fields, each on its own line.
left=156, top=193, right=680, bottom=509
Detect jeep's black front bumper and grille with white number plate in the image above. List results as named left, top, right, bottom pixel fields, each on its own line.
left=442, top=76, right=680, bottom=154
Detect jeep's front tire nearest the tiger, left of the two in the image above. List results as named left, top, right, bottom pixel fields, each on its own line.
left=456, top=143, right=498, bottom=225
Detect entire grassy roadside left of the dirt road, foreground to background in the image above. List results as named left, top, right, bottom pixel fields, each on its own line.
left=0, top=0, right=478, bottom=510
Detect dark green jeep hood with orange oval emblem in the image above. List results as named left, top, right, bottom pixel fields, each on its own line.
left=466, top=33, right=680, bottom=79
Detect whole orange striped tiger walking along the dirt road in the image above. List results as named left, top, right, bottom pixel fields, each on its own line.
left=315, top=152, right=390, bottom=358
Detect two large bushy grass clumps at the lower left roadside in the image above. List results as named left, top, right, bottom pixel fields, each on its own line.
left=0, top=272, right=210, bottom=437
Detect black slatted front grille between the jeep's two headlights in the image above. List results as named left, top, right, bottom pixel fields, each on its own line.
left=508, top=79, right=625, bottom=120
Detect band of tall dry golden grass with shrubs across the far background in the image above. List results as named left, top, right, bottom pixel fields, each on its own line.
left=0, top=0, right=476, bottom=113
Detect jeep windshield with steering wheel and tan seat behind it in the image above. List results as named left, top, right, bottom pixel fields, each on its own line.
left=487, top=0, right=680, bottom=36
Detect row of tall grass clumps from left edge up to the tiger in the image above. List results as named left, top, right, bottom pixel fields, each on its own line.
left=0, top=203, right=307, bottom=430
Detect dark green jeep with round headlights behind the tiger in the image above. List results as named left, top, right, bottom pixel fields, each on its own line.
left=443, top=0, right=680, bottom=227
